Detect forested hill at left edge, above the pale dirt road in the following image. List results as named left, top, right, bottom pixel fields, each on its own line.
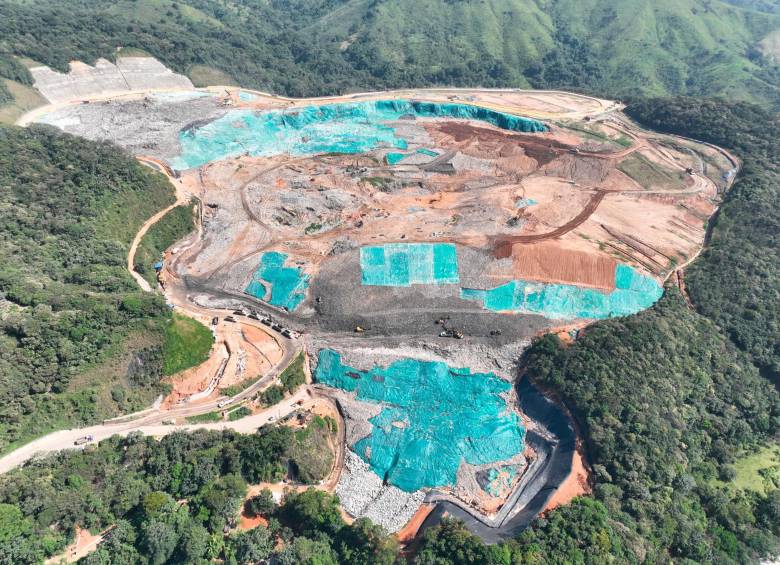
left=0, top=126, right=211, bottom=451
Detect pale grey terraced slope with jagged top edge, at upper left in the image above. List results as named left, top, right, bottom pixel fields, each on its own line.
left=30, top=57, right=194, bottom=103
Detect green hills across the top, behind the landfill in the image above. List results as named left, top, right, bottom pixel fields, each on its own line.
left=0, top=0, right=780, bottom=107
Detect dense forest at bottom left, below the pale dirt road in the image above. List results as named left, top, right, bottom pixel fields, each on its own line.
left=0, top=426, right=398, bottom=565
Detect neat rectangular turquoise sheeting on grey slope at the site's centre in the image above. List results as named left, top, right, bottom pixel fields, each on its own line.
left=360, top=243, right=460, bottom=286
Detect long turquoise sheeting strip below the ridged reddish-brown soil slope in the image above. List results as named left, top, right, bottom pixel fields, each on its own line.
left=460, top=265, right=663, bottom=319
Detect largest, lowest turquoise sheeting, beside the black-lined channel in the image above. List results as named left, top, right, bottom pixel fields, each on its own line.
left=314, top=349, right=525, bottom=492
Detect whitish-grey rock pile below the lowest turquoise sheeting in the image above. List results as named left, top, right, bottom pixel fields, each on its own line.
left=336, top=450, right=425, bottom=533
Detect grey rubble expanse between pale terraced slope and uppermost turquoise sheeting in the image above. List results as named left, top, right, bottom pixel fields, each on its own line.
left=38, top=95, right=227, bottom=160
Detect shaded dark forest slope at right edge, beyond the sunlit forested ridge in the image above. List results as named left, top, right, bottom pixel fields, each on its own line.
left=629, top=99, right=780, bottom=385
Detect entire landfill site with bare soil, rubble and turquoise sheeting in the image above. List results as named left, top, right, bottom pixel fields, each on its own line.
left=27, top=60, right=738, bottom=542
